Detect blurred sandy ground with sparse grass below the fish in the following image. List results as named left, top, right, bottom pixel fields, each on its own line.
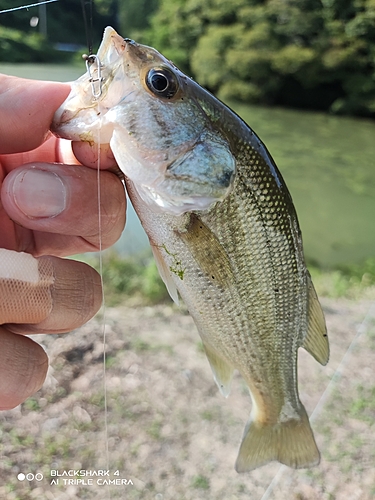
left=0, top=299, right=375, bottom=500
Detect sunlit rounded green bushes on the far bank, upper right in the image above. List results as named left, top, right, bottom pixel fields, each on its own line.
left=147, top=0, right=375, bottom=115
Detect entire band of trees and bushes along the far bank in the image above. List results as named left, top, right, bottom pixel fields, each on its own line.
left=0, top=0, right=375, bottom=116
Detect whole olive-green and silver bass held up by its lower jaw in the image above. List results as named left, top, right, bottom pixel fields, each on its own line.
left=52, top=27, right=329, bottom=472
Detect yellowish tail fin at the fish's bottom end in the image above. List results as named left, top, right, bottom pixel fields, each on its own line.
left=235, top=405, right=320, bottom=472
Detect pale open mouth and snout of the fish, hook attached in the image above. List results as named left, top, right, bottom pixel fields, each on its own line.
left=51, top=27, right=180, bottom=143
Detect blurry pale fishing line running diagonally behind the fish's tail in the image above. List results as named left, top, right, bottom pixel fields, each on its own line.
left=260, top=302, right=375, bottom=500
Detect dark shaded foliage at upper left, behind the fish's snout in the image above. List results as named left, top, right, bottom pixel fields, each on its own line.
left=0, top=0, right=157, bottom=62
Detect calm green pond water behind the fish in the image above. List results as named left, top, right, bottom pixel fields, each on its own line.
left=0, top=63, right=375, bottom=266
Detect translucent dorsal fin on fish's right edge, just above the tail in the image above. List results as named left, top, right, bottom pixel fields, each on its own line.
left=302, top=273, right=329, bottom=365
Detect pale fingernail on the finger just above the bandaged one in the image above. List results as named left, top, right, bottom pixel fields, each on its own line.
left=13, top=168, right=66, bottom=218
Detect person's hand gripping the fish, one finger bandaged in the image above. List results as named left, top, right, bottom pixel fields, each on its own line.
left=0, top=75, right=125, bottom=409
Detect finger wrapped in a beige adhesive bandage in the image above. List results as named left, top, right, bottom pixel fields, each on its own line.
left=0, top=249, right=102, bottom=334
